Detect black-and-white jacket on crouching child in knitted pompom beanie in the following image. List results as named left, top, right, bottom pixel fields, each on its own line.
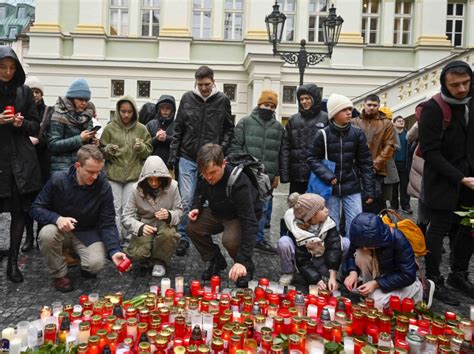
left=284, top=208, right=342, bottom=284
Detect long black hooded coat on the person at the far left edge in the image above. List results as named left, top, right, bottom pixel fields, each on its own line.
left=0, top=46, right=42, bottom=198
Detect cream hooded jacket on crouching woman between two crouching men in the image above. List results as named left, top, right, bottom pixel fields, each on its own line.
left=122, top=156, right=183, bottom=235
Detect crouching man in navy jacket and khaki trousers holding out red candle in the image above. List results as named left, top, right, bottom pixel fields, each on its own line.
left=31, top=145, right=127, bottom=292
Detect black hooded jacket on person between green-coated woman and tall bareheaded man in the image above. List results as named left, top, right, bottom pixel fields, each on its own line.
left=146, top=95, right=176, bottom=163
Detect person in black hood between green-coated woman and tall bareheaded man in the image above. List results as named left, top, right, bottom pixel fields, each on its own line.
left=146, top=95, right=176, bottom=165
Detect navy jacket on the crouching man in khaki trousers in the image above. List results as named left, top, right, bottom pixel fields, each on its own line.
left=30, top=166, right=121, bottom=257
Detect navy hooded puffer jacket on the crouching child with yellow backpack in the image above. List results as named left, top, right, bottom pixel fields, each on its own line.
left=346, top=213, right=416, bottom=292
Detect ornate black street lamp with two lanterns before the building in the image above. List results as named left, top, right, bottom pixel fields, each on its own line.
left=265, top=0, right=344, bottom=85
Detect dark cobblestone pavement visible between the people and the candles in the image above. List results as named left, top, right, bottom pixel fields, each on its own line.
left=0, top=185, right=474, bottom=330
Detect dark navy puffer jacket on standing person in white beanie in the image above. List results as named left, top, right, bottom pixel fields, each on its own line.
left=308, top=121, right=375, bottom=198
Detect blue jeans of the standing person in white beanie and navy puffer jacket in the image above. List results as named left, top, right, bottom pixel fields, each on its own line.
left=326, top=193, right=362, bottom=237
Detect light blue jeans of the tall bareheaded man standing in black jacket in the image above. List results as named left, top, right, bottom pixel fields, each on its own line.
left=178, top=157, right=198, bottom=242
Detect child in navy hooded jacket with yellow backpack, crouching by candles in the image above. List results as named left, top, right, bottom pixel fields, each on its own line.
left=344, top=213, right=423, bottom=310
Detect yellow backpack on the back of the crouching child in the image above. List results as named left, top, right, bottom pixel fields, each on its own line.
left=379, top=209, right=426, bottom=257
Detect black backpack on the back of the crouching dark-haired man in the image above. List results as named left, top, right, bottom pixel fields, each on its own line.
left=226, top=153, right=272, bottom=202
